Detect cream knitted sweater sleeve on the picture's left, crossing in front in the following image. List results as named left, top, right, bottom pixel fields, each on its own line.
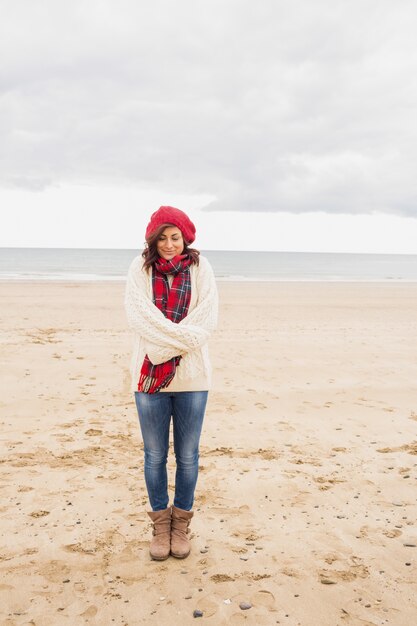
left=125, top=257, right=216, bottom=364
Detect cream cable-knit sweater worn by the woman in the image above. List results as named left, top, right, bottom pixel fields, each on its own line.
left=125, top=256, right=218, bottom=392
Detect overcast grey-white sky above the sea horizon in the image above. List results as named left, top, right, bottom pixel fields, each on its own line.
left=0, top=0, right=417, bottom=253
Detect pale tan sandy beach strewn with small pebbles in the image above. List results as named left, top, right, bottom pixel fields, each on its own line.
left=0, top=282, right=417, bottom=626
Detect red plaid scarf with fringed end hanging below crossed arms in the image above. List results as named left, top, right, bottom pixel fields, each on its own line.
left=138, top=254, right=191, bottom=393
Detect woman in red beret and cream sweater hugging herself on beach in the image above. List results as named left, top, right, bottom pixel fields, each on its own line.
left=125, top=206, right=218, bottom=561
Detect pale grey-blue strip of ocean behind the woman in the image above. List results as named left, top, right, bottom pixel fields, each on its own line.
left=0, top=248, right=417, bottom=282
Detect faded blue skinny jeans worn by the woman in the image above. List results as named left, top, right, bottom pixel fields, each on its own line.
left=135, top=391, right=208, bottom=511
